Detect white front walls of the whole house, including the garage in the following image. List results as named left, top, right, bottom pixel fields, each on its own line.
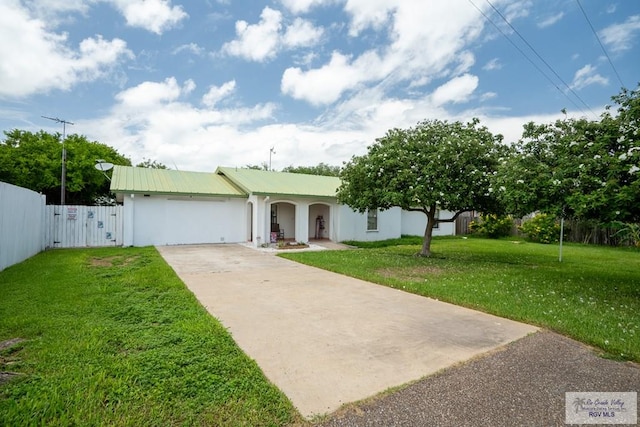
left=123, top=194, right=455, bottom=246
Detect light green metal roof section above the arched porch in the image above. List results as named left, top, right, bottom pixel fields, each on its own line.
left=216, top=167, right=340, bottom=197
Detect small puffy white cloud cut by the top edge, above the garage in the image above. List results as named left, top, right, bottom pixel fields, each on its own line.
left=110, top=0, right=188, bottom=34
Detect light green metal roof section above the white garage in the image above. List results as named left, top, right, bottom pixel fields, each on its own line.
left=111, top=166, right=247, bottom=197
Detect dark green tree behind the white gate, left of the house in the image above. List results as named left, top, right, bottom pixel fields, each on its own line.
left=0, top=129, right=131, bottom=205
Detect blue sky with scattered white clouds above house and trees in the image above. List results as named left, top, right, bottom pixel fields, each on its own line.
left=0, top=0, right=640, bottom=171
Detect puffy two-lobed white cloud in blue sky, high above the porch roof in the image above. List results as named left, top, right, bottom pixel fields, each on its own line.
left=222, top=7, right=324, bottom=62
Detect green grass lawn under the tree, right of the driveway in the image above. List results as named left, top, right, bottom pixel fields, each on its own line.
left=280, top=237, right=640, bottom=362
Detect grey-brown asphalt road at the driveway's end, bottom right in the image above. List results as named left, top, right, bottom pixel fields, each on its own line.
left=318, top=331, right=640, bottom=427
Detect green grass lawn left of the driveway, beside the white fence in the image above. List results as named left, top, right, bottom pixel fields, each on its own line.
left=0, top=248, right=300, bottom=426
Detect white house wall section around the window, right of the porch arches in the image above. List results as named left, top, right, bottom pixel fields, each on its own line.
left=335, top=205, right=402, bottom=242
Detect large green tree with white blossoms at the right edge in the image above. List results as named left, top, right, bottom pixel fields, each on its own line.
left=495, top=84, right=640, bottom=223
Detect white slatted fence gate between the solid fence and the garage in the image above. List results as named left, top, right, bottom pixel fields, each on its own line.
left=45, top=205, right=123, bottom=248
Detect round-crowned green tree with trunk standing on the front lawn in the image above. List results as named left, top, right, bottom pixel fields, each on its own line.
left=338, top=119, right=505, bottom=256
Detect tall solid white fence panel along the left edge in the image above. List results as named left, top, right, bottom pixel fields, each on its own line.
left=0, top=182, right=45, bottom=271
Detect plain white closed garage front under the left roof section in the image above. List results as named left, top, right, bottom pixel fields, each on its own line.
left=123, top=194, right=247, bottom=246
